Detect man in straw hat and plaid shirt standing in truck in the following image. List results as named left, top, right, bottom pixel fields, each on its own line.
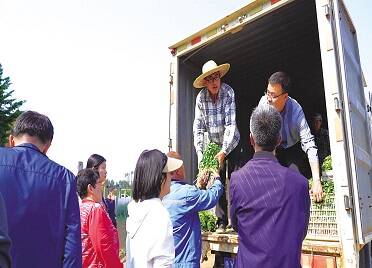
left=193, top=60, right=240, bottom=232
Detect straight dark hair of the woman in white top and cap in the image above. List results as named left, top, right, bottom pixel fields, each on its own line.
left=133, top=150, right=168, bottom=202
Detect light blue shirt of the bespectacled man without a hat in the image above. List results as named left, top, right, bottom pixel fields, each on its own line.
left=259, top=96, right=318, bottom=163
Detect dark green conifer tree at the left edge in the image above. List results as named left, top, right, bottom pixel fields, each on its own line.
left=0, top=64, right=25, bottom=146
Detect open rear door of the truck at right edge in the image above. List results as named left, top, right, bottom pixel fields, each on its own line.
left=332, top=0, right=372, bottom=245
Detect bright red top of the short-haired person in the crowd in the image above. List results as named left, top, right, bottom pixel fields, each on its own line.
left=80, top=199, right=123, bottom=268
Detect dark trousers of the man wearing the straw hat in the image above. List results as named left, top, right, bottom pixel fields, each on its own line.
left=216, top=145, right=240, bottom=227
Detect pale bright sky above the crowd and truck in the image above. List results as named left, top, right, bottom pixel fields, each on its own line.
left=0, top=0, right=372, bottom=180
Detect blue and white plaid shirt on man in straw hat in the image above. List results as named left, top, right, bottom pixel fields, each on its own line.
left=193, top=83, right=240, bottom=155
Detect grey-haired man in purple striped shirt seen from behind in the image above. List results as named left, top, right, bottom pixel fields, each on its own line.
left=230, top=105, right=310, bottom=268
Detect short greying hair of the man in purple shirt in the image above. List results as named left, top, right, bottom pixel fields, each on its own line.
left=250, top=105, right=282, bottom=152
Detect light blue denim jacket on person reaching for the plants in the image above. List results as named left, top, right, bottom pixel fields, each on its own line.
left=163, top=179, right=223, bottom=268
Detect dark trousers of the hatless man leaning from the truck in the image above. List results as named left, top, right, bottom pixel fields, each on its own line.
left=276, top=142, right=312, bottom=179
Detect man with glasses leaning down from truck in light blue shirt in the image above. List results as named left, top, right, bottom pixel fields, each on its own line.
left=259, top=72, right=323, bottom=202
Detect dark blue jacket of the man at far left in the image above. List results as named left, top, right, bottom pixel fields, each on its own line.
left=0, top=143, right=82, bottom=268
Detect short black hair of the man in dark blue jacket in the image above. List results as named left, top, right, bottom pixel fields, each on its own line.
left=11, top=111, right=54, bottom=144
